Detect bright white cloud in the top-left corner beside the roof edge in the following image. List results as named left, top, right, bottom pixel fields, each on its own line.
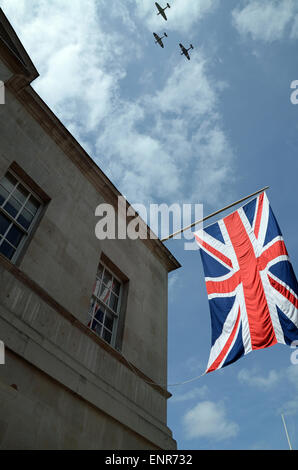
left=0, top=0, right=133, bottom=131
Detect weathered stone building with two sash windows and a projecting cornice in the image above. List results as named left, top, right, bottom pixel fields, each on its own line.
left=0, top=10, right=180, bottom=449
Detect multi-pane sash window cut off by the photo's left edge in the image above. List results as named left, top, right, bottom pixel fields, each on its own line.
left=0, top=171, right=42, bottom=262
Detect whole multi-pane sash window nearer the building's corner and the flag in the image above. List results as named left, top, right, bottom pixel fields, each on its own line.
left=88, top=263, right=122, bottom=346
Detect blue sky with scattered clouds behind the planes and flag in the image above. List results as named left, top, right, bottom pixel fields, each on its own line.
left=0, top=0, right=298, bottom=449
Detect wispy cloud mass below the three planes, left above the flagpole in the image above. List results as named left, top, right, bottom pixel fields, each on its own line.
left=97, top=53, right=234, bottom=204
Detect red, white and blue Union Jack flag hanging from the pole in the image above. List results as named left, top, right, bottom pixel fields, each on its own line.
left=195, top=193, right=298, bottom=373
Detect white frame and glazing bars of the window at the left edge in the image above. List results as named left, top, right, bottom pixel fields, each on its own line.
left=0, top=168, right=45, bottom=264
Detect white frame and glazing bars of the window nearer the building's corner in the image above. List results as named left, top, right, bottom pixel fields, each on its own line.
left=87, top=260, right=123, bottom=348
